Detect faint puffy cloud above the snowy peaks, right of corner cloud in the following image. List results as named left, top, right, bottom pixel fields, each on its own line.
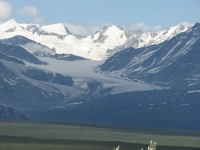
left=18, top=6, right=45, bottom=24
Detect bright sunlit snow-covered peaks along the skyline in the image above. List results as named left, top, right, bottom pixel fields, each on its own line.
left=0, top=19, right=190, bottom=60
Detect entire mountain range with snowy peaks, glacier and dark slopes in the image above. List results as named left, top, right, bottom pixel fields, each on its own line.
left=0, top=19, right=200, bottom=130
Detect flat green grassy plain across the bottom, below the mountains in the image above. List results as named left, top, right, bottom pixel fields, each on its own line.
left=0, top=121, right=200, bottom=150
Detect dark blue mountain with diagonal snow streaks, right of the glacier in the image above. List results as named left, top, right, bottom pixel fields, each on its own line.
left=100, top=23, right=200, bottom=88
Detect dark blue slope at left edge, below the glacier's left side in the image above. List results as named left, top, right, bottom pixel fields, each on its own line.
left=0, top=60, right=65, bottom=112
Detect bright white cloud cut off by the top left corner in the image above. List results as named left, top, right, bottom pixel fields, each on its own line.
left=0, top=0, right=12, bottom=19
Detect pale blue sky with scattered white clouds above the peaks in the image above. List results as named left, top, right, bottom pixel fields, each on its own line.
left=0, top=0, right=200, bottom=35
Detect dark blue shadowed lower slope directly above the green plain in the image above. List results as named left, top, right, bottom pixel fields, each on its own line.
left=31, top=90, right=200, bottom=130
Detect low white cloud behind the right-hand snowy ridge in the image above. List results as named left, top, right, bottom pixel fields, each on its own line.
left=124, top=22, right=162, bottom=32
